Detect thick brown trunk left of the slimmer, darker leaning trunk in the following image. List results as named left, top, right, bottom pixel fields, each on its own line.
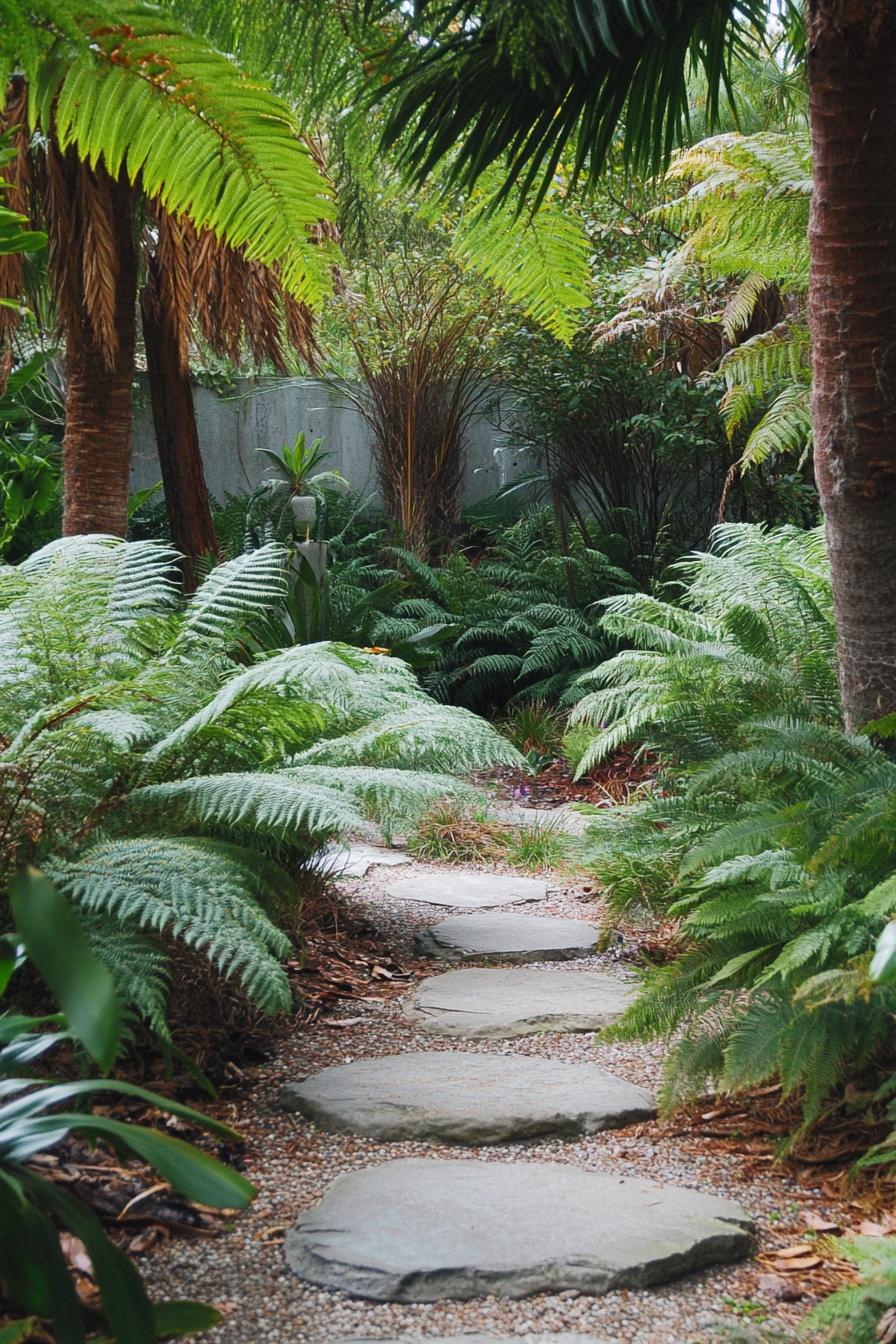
left=58, top=165, right=137, bottom=536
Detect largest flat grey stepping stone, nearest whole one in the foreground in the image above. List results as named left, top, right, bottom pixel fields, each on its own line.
left=285, top=1157, right=752, bottom=1302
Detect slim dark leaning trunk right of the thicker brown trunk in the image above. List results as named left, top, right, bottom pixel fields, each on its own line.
left=141, top=262, right=218, bottom=591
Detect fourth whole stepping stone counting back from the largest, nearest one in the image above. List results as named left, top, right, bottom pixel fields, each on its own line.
left=416, top=914, right=598, bottom=961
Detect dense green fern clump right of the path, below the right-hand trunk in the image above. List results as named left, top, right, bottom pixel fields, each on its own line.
left=575, top=526, right=896, bottom=1121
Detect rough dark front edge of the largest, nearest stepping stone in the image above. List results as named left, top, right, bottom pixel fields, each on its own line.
left=283, top=1218, right=754, bottom=1302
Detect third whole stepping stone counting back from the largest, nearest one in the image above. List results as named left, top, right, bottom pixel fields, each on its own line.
left=404, top=966, right=634, bottom=1040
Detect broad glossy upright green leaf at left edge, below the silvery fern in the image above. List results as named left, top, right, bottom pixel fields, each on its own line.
left=9, top=868, right=120, bottom=1070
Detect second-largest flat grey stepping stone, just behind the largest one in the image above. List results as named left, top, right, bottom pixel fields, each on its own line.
left=281, top=1050, right=656, bottom=1144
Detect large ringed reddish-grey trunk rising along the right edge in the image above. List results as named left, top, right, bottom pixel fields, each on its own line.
left=809, top=0, right=896, bottom=728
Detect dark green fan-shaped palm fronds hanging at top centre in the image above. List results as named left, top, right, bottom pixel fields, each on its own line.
left=368, top=0, right=770, bottom=198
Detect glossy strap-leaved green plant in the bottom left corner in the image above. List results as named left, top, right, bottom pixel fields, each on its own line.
left=0, top=870, right=254, bottom=1344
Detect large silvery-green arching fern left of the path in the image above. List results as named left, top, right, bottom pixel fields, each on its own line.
left=0, top=536, right=517, bottom=1038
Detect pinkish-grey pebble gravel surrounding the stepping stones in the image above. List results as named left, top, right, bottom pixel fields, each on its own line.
left=142, top=864, right=833, bottom=1344
